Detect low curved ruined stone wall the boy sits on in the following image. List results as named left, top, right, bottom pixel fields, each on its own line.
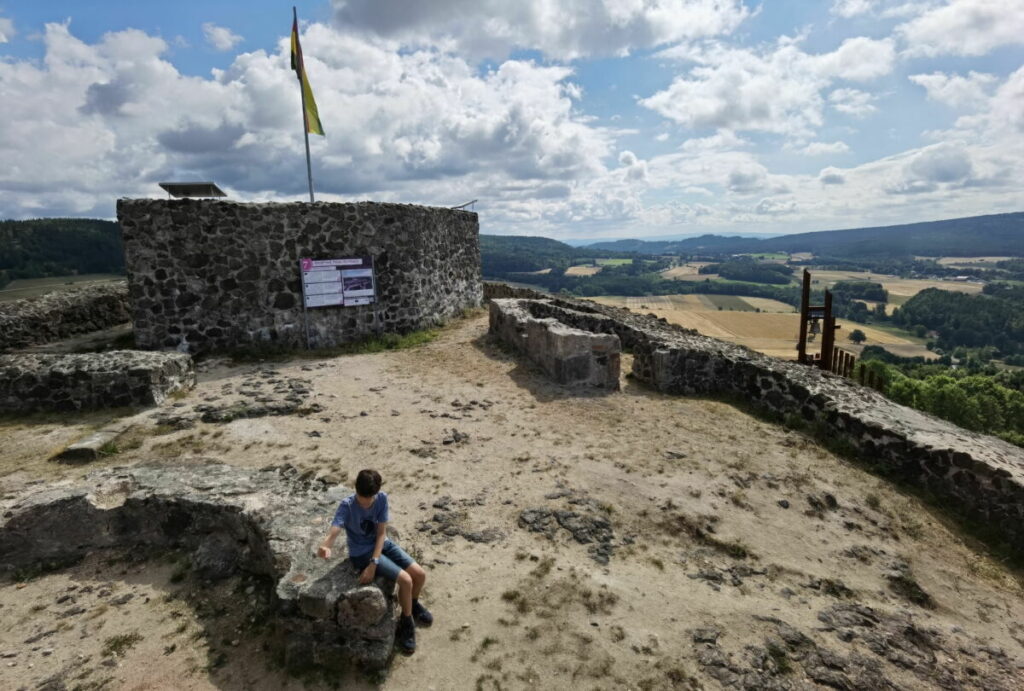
left=0, top=464, right=397, bottom=670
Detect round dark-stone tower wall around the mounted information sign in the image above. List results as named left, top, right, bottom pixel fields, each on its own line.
left=118, top=200, right=482, bottom=352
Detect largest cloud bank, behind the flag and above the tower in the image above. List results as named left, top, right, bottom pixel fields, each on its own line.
left=0, top=24, right=614, bottom=218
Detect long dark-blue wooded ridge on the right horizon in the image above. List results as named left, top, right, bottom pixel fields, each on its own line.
left=584, top=212, right=1024, bottom=257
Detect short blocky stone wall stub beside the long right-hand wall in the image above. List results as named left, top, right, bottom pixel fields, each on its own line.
left=490, top=299, right=622, bottom=391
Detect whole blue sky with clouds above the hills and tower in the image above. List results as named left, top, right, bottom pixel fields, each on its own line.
left=0, top=0, right=1024, bottom=240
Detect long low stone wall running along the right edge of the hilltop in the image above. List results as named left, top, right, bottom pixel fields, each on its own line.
left=491, top=299, right=1024, bottom=555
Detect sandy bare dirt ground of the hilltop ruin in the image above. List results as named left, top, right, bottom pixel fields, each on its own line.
left=0, top=313, right=1024, bottom=689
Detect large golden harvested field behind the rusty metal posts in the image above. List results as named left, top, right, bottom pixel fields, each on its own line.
left=593, top=295, right=935, bottom=359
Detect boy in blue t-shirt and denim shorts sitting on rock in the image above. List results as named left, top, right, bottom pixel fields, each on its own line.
left=316, top=470, right=434, bottom=653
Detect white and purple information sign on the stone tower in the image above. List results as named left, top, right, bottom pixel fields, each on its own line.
left=299, top=257, right=377, bottom=308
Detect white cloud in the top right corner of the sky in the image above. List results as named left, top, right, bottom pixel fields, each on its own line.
left=896, top=0, right=1024, bottom=55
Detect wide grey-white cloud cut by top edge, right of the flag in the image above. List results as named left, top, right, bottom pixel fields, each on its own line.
left=332, top=0, right=750, bottom=59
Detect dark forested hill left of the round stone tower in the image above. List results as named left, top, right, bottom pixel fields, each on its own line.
left=0, top=218, right=125, bottom=286
